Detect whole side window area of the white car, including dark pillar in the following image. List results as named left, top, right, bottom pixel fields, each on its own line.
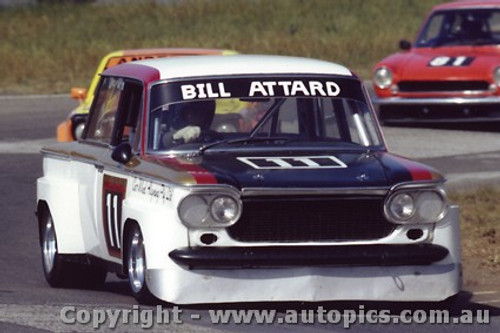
left=86, top=77, right=142, bottom=148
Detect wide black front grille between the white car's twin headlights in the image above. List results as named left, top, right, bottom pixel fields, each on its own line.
left=228, top=196, right=394, bottom=243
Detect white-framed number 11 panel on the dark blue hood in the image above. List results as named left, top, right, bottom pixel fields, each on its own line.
left=237, top=156, right=347, bottom=169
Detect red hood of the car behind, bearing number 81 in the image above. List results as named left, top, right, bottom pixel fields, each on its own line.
left=376, top=46, right=500, bottom=81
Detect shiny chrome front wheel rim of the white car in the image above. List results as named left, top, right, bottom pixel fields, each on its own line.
left=128, top=230, right=146, bottom=293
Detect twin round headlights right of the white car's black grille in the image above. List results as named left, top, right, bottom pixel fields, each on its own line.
left=384, top=188, right=447, bottom=224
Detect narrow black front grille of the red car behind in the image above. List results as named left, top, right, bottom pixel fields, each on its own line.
left=398, top=81, right=490, bottom=92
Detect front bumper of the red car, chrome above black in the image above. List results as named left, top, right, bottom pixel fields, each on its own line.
left=372, top=96, right=500, bottom=123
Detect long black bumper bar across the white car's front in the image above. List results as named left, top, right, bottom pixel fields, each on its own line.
left=169, top=244, right=449, bottom=269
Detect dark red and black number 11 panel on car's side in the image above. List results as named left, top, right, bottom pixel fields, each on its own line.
left=102, top=175, right=127, bottom=258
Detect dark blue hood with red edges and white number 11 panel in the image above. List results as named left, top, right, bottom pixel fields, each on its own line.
left=147, top=151, right=443, bottom=189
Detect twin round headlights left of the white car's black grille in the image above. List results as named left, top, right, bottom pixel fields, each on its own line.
left=177, top=192, right=241, bottom=228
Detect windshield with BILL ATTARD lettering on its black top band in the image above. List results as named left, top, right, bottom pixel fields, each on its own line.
left=148, top=78, right=382, bottom=152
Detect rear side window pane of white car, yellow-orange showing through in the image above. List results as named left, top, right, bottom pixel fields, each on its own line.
left=86, top=77, right=124, bottom=144
